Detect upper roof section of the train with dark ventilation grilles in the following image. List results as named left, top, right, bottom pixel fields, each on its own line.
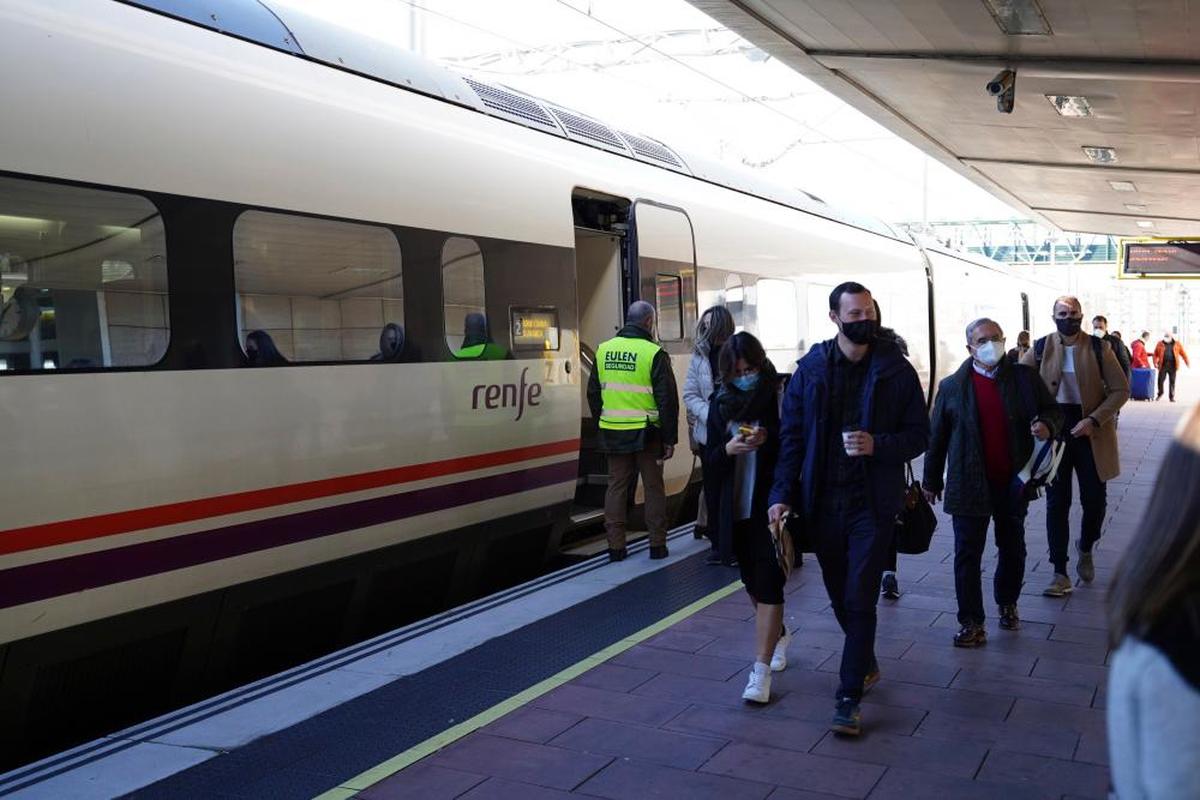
left=116, top=0, right=911, bottom=241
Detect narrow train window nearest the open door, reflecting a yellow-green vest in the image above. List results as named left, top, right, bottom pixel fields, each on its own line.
left=442, top=236, right=496, bottom=360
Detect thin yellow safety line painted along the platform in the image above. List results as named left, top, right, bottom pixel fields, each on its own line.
left=314, top=581, right=742, bottom=800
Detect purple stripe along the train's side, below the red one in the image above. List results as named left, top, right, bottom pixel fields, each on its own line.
left=0, top=461, right=578, bottom=608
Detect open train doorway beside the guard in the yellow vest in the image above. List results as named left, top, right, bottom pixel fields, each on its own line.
left=571, top=190, right=634, bottom=527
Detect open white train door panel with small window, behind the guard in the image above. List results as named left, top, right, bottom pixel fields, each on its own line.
left=630, top=199, right=696, bottom=495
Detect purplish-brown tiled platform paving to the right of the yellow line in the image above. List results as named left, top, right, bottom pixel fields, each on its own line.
left=359, top=391, right=1196, bottom=800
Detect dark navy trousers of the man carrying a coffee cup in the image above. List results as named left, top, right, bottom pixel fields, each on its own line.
left=816, top=497, right=895, bottom=700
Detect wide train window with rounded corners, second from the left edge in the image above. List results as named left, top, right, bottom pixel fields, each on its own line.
left=233, top=211, right=404, bottom=366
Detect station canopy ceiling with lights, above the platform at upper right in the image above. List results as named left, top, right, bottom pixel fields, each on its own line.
left=689, top=0, right=1200, bottom=237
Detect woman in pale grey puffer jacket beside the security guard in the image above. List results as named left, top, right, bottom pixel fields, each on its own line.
left=683, top=306, right=733, bottom=566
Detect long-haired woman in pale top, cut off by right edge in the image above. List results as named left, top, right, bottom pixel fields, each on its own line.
left=1108, top=408, right=1200, bottom=800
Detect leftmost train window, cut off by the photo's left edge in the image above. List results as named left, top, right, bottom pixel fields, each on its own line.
left=0, top=176, right=169, bottom=372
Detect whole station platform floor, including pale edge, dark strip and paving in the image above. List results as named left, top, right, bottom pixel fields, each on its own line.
left=0, top=381, right=1198, bottom=800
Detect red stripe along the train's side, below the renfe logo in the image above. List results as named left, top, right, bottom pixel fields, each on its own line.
left=0, top=439, right=580, bottom=555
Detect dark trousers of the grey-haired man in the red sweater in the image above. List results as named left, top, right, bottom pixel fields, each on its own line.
left=954, top=488, right=1030, bottom=625
